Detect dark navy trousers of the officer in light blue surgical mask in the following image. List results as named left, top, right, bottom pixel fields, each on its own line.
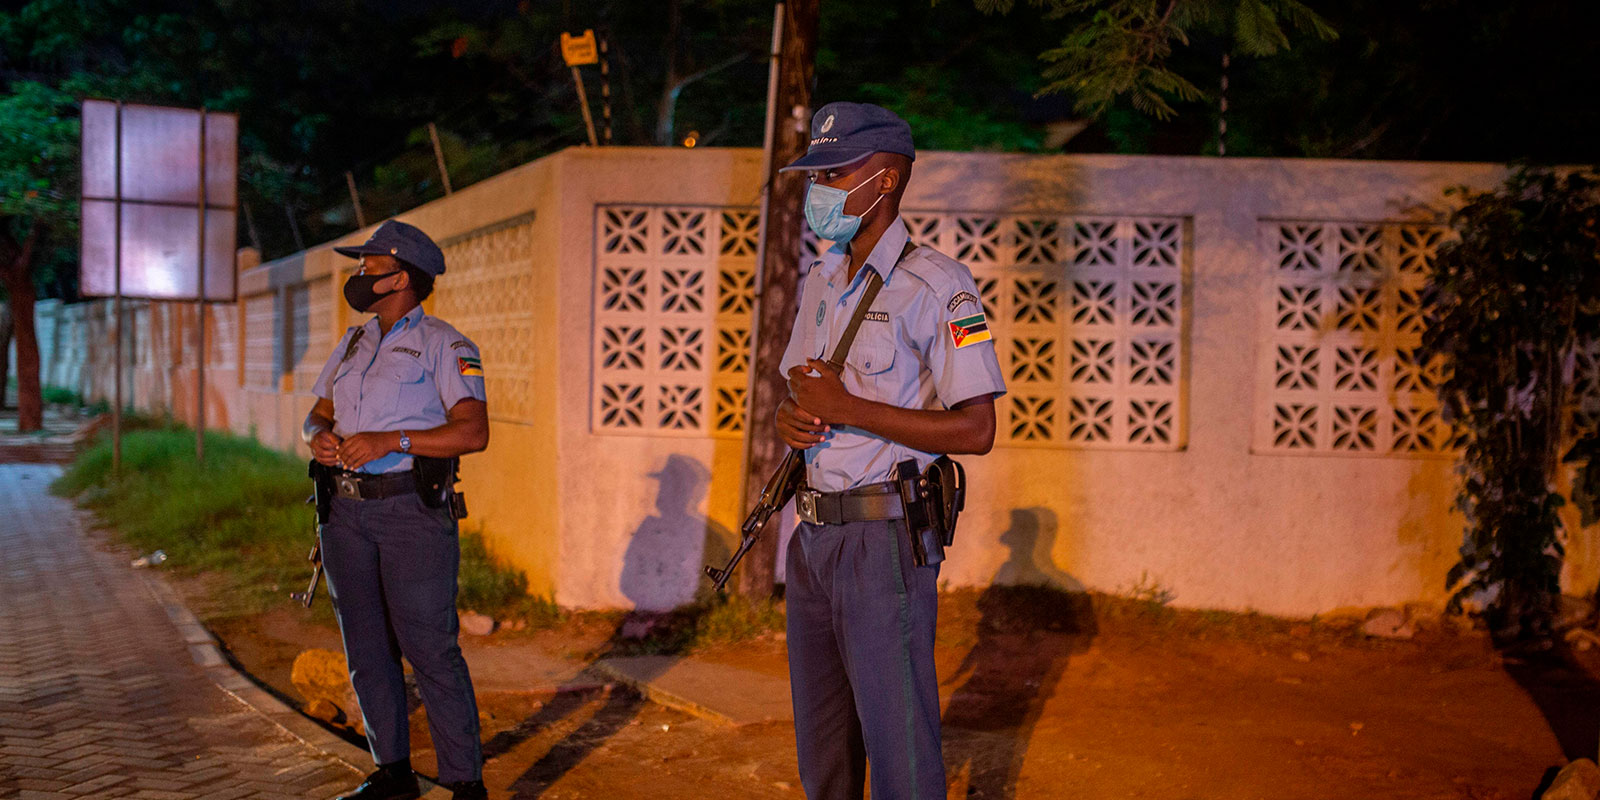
left=784, top=520, right=944, bottom=800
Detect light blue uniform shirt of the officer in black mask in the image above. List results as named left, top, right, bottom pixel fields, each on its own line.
left=312, top=306, right=485, bottom=472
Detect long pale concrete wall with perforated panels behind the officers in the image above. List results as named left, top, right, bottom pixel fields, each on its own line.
left=40, top=149, right=1600, bottom=614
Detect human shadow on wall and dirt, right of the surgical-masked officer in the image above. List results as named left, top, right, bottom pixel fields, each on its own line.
left=941, top=507, right=1098, bottom=798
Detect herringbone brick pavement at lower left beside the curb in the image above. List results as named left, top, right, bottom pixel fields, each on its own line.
left=0, top=464, right=358, bottom=800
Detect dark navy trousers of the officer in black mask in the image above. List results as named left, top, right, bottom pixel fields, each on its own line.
left=322, top=493, right=483, bottom=782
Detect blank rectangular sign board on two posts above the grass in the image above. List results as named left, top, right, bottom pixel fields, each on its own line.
left=78, top=101, right=238, bottom=301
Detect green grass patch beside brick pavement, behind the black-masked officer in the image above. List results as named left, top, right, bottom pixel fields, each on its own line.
left=51, top=422, right=560, bottom=626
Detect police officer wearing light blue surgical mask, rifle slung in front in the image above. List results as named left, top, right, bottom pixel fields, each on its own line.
left=776, top=102, right=1005, bottom=800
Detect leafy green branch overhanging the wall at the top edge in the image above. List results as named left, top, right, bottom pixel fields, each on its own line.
left=974, top=0, right=1338, bottom=120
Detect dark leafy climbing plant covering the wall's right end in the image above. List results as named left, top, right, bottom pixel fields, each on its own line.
left=1422, top=170, right=1600, bottom=640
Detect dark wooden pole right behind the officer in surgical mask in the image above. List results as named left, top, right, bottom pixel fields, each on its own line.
left=739, top=0, right=818, bottom=598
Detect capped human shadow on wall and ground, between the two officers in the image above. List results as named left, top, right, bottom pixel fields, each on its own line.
left=483, top=454, right=731, bottom=800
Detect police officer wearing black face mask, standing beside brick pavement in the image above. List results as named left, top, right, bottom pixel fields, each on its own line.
left=302, top=221, right=490, bottom=800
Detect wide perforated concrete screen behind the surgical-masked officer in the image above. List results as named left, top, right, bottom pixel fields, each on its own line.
left=590, top=205, right=1189, bottom=450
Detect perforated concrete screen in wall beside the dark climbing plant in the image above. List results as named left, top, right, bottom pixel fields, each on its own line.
left=1254, top=219, right=1456, bottom=456
